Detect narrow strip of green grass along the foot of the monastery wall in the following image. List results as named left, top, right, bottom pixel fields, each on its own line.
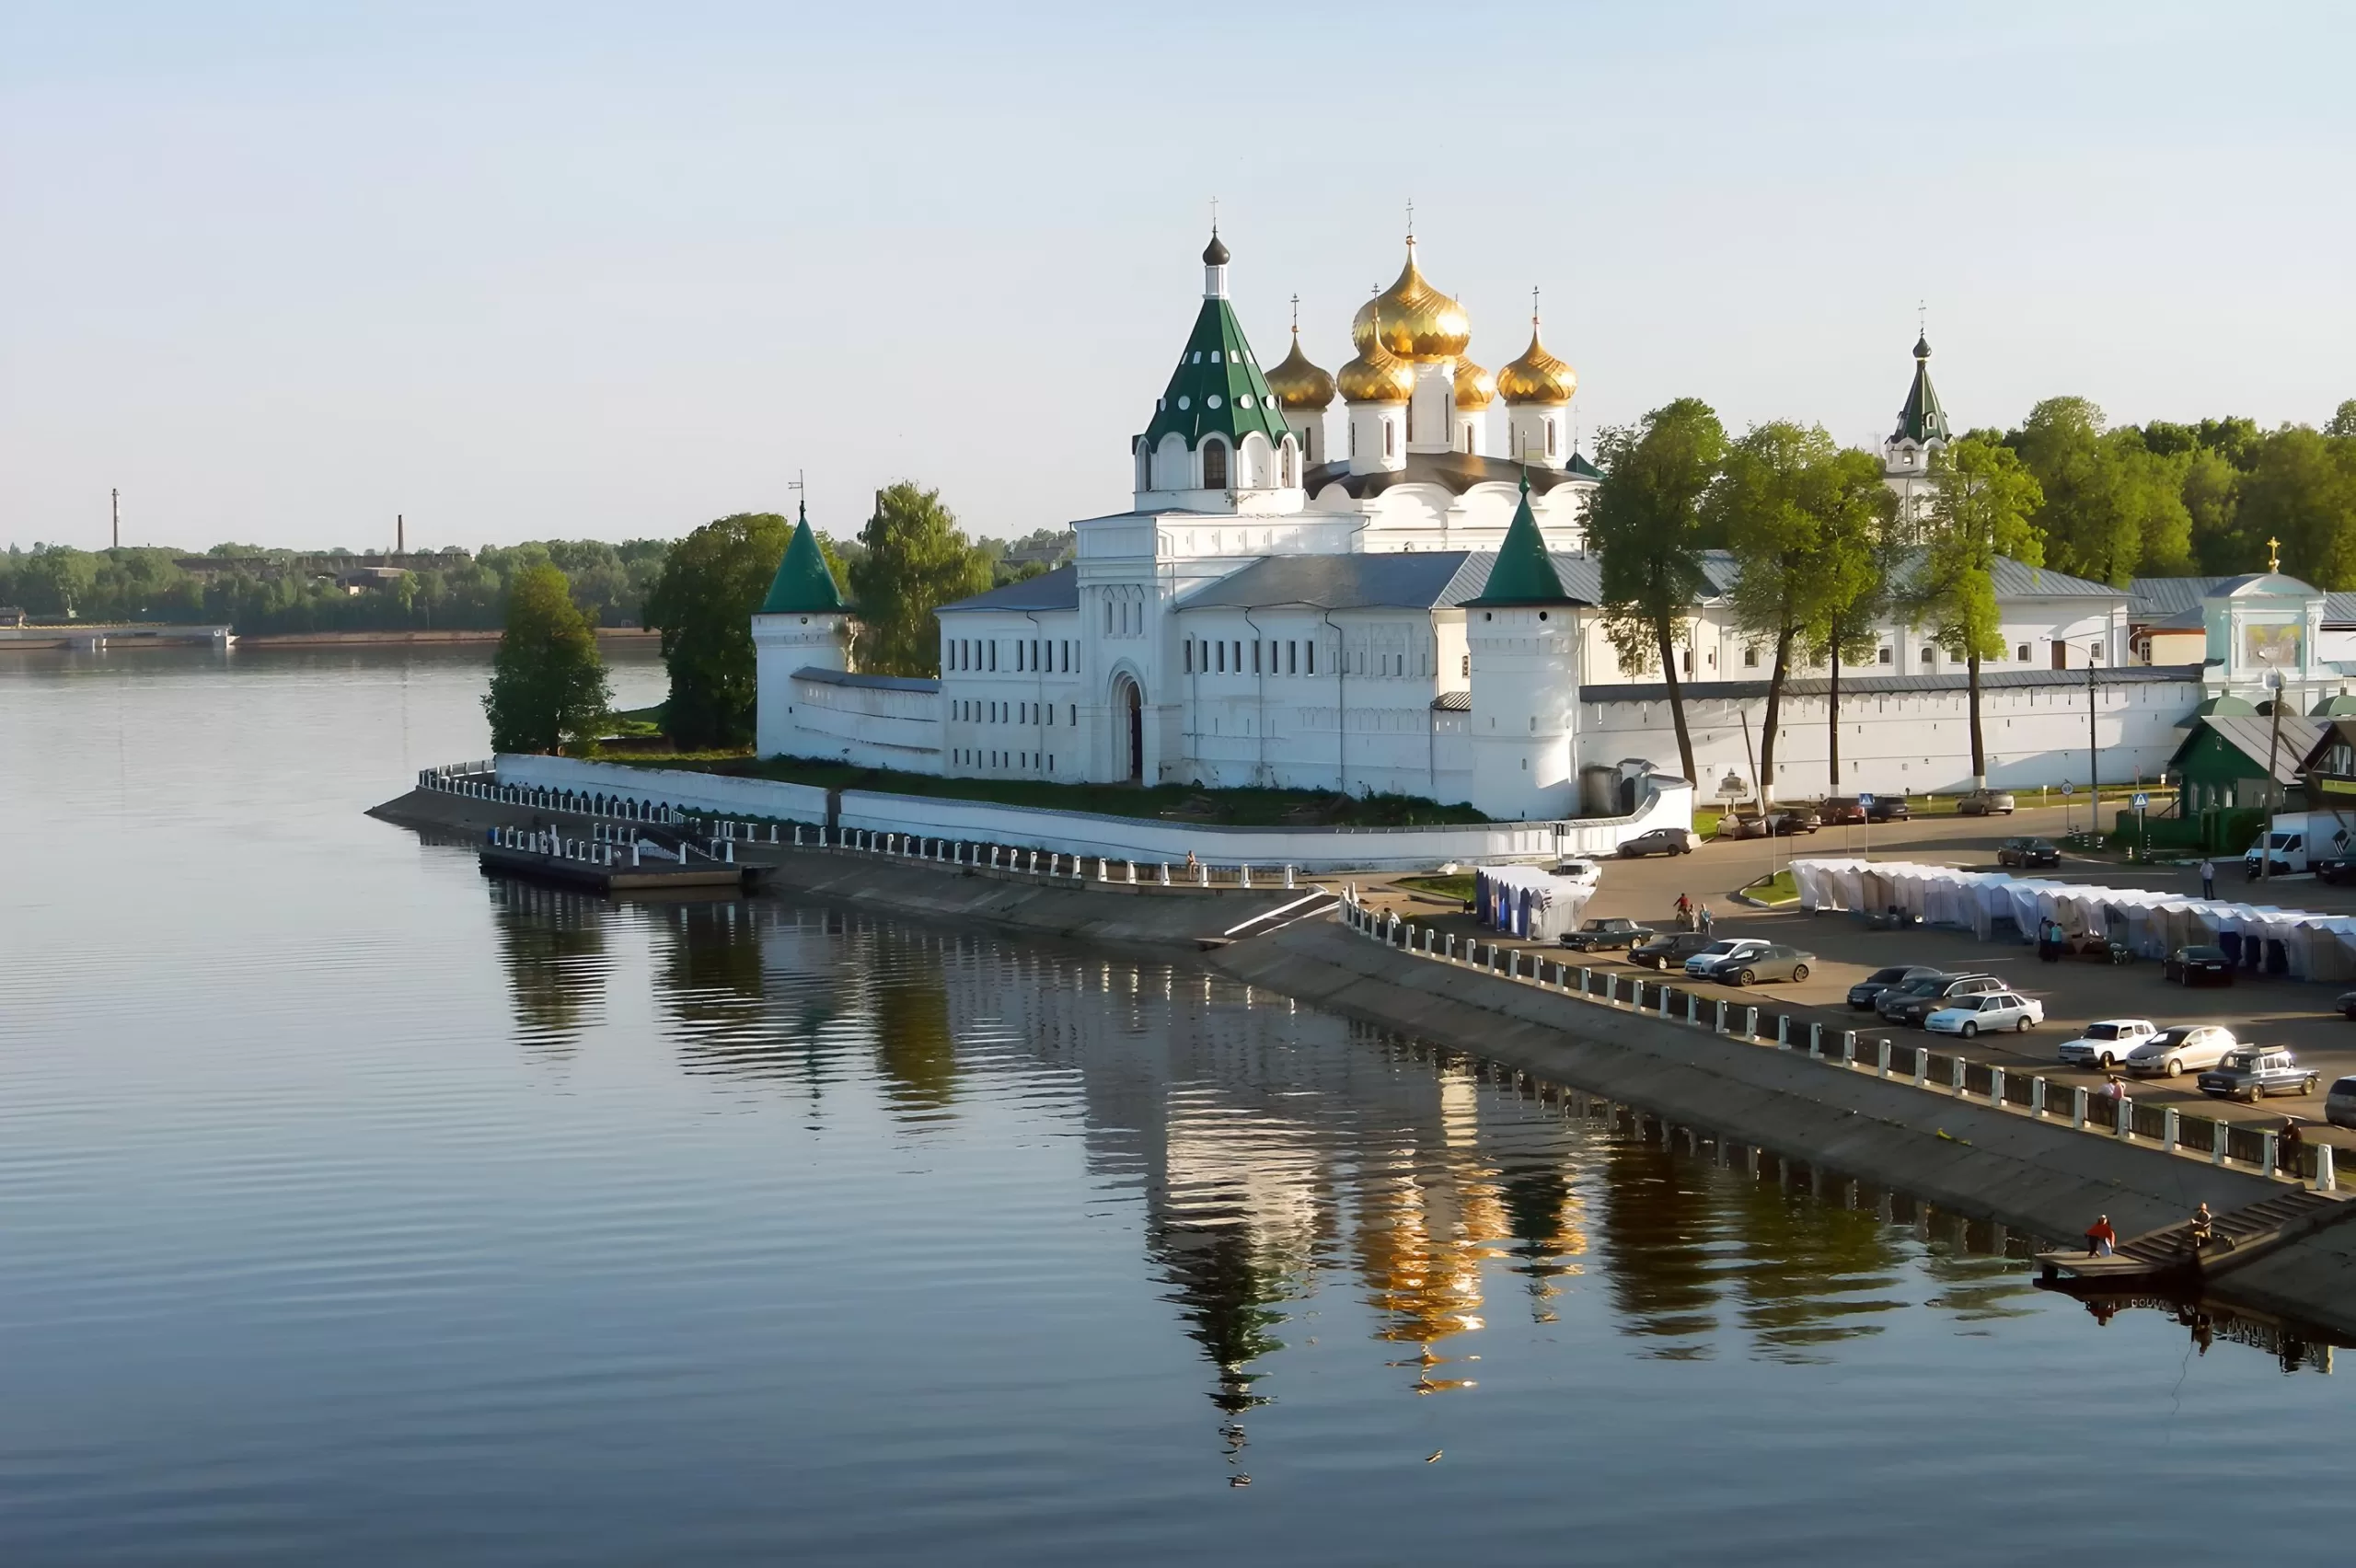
left=606, top=751, right=1486, bottom=826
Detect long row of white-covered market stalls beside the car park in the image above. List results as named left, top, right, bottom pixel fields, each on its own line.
left=1791, top=859, right=2356, bottom=979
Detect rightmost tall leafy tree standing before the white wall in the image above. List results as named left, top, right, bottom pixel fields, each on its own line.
left=1906, top=435, right=2045, bottom=789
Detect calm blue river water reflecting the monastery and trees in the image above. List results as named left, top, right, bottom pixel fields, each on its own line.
left=0, top=652, right=2356, bottom=1568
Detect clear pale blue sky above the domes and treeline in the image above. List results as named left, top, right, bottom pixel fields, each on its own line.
left=0, top=0, right=2356, bottom=548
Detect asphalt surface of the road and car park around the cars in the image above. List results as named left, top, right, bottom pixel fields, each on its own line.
left=1364, top=808, right=2356, bottom=1142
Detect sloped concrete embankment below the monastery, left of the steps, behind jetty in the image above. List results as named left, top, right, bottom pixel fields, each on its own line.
left=370, top=789, right=1314, bottom=951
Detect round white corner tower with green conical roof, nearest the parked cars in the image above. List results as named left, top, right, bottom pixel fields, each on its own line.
left=1463, top=478, right=1578, bottom=822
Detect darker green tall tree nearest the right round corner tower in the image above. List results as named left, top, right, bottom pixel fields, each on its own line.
left=1588, top=398, right=1727, bottom=784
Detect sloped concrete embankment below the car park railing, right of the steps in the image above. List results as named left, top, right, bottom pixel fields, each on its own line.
left=1211, top=920, right=2356, bottom=1335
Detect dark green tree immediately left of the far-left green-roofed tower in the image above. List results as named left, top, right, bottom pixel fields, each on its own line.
left=645, top=511, right=794, bottom=751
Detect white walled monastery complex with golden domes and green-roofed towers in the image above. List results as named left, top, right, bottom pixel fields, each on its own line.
left=752, top=236, right=2299, bottom=819
